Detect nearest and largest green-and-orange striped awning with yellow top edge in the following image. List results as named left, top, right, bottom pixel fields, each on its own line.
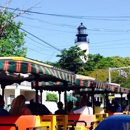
left=0, top=57, right=75, bottom=84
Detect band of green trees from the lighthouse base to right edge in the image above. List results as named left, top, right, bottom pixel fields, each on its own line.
left=55, top=46, right=130, bottom=88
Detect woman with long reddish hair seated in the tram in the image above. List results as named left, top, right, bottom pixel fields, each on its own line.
left=9, top=95, right=32, bottom=116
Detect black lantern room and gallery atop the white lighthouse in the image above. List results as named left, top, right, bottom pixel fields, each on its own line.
left=76, top=23, right=88, bottom=42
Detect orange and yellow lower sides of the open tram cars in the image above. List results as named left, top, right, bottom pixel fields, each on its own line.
left=0, top=111, right=130, bottom=130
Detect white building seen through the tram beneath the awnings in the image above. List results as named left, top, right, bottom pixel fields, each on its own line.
left=0, top=81, right=64, bottom=105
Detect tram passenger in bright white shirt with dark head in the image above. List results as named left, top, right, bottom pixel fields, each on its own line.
left=73, top=98, right=93, bottom=115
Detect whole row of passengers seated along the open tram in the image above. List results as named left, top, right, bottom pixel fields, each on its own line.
left=0, top=95, right=130, bottom=116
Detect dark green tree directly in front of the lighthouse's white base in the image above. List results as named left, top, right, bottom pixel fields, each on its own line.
left=57, top=46, right=86, bottom=74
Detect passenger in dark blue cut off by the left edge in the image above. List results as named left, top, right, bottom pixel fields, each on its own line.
left=0, top=95, right=9, bottom=116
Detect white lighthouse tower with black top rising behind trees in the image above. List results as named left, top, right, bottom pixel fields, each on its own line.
left=75, top=23, right=89, bottom=62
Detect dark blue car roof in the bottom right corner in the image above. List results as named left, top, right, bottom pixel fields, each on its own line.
left=94, top=114, right=130, bottom=130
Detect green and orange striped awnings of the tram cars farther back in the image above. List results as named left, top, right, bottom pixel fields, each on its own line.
left=32, top=79, right=130, bottom=93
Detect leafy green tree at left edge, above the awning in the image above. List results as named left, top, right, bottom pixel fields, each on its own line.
left=0, top=11, right=27, bottom=57
